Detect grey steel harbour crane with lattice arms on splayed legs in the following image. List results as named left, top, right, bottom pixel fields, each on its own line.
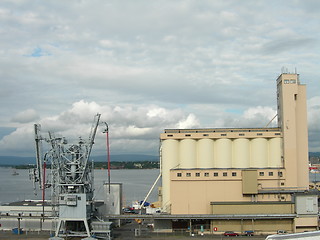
left=33, top=114, right=100, bottom=239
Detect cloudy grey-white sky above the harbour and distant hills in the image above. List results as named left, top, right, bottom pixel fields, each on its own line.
left=0, top=0, right=320, bottom=156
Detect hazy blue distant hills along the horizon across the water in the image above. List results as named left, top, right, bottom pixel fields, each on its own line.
left=0, top=154, right=159, bottom=166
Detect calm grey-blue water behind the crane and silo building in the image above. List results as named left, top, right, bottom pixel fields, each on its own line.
left=0, top=168, right=160, bottom=205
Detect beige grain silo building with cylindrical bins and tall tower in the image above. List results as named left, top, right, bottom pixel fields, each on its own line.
left=159, top=73, right=318, bottom=234
